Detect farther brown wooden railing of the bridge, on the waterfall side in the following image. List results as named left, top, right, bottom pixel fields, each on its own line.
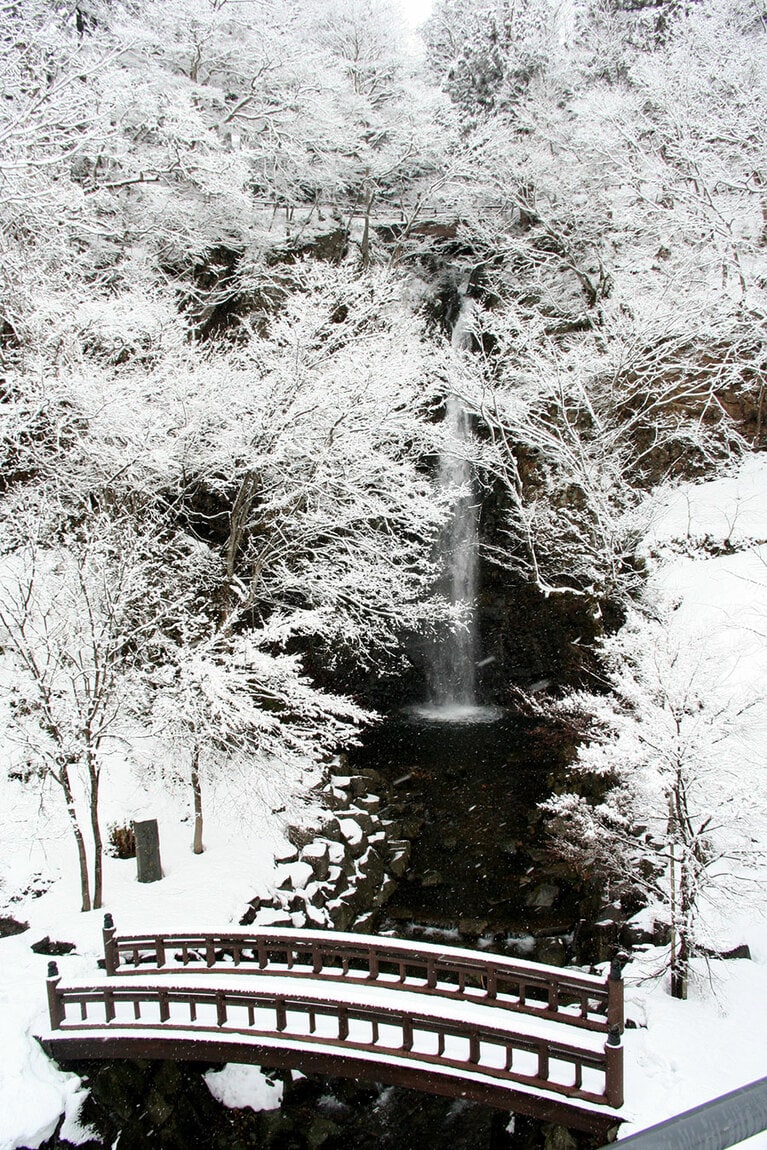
left=103, top=915, right=623, bottom=1033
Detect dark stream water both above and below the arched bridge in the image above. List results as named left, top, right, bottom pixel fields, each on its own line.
left=257, top=707, right=592, bottom=1150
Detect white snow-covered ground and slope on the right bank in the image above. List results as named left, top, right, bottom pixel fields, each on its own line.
left=622, top=455, right=767, bottom=1148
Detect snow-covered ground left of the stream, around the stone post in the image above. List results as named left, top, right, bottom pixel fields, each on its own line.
left=0, top=765, right=305, bottom=1150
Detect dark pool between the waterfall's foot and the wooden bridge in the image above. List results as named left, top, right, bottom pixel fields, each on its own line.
left=355, top=710, right=578, bottom=961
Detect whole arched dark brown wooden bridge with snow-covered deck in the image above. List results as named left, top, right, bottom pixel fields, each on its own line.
left=40, top=915, right=623, bottom=1139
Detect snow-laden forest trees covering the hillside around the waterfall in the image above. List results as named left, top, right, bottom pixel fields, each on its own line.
left=0, top=0, right=767, bottom=970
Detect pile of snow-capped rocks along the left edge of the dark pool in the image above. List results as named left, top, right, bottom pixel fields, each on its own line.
left=240, top=760, right=421, bottom=930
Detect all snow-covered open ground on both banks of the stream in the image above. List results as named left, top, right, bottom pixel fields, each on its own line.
left=0, top=455, right=767, bottom=1150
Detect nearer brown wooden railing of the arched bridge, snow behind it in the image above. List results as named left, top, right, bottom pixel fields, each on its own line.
left=47, top=963, right=623, bottom=1107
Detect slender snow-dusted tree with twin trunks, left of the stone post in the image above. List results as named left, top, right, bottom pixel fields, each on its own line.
left=0, top=516, right=171, bottom=911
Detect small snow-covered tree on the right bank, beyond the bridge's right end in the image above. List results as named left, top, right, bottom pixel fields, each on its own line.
left=544, top=610, right=767, bottom=998
